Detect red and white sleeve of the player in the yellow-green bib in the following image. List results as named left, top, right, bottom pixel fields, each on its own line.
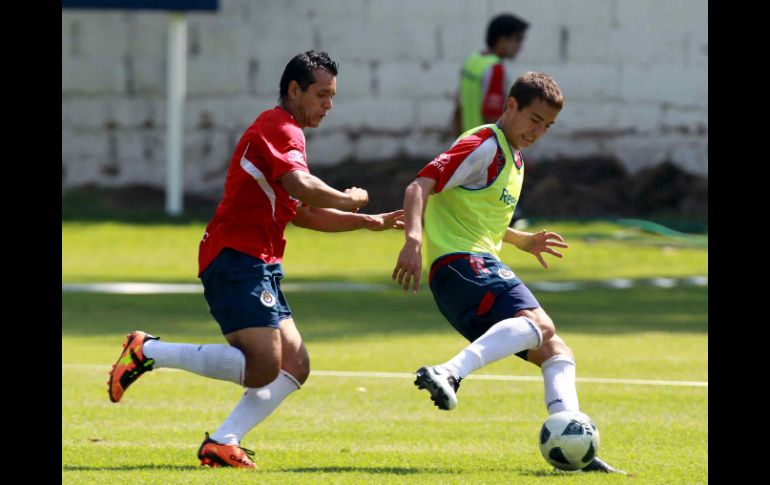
left=417, top=129, right=496, bottom=193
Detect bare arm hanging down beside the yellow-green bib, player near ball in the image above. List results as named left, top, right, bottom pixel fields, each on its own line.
left=391, top=177, right=436, bottom=293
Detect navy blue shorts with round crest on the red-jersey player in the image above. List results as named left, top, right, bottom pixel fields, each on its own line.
left=200, top=248, right=291, bottom=335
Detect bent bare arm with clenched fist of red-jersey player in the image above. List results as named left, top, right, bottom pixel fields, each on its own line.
left=280, top=170, right=369, bottom=210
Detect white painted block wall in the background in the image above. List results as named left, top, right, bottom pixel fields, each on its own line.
left=62, top=0, right=708, bottom=193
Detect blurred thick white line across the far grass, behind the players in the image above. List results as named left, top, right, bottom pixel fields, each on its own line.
left=61, top=276, right=708, bottom=295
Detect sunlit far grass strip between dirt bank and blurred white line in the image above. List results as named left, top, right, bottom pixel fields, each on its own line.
left=62, top=221, right=708, bottom=283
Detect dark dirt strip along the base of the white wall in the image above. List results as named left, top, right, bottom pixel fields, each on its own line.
left=62, top=157, right=708, bottom=223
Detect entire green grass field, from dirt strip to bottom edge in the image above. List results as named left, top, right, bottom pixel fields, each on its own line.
left=62, top=218, right=708, bottom=484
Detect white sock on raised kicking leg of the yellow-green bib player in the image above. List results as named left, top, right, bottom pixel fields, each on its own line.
left=442, top=317, right=543, bottom=378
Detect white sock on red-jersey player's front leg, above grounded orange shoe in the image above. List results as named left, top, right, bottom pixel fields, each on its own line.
left=211, top=370, right=302, bottom=445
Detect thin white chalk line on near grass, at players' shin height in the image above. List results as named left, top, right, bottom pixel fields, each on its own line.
left=62, top=364, right=709, bottom=387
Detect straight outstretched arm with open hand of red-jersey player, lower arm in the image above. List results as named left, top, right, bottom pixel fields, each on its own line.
left=292, top=206, right=404, bottom=232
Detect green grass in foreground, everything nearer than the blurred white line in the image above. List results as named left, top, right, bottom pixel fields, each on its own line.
left=62, top=288, right=708, bottom=484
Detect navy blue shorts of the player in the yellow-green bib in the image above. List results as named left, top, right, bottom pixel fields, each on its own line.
left=430, top=253, right=540, bottom=360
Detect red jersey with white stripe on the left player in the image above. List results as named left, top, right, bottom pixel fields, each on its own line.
left=198, top=106, right=310, bottom=275
